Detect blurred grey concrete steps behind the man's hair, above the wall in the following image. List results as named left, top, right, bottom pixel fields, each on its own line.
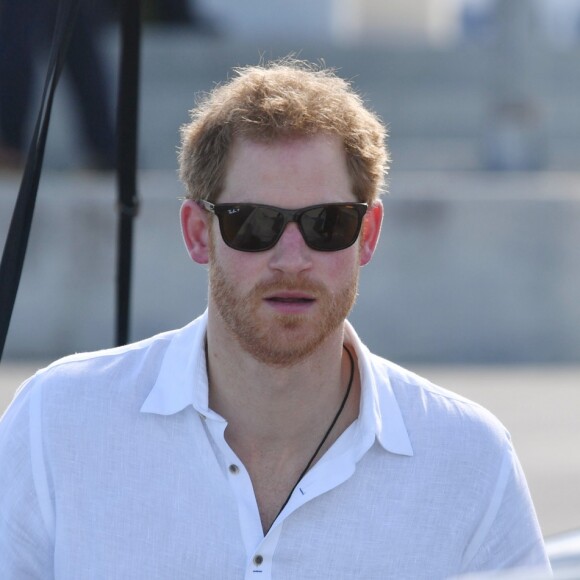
left=19, top=26, right=580, bottom=170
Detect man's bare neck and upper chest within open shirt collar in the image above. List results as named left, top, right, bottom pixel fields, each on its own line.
left=207, top=314, right=360, bottom=532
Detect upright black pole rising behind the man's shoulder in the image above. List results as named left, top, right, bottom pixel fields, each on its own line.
left=116, top=0, right=141, bottom=345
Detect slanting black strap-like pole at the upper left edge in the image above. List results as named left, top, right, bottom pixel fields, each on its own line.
left=0, top=0, right=82, bottom=359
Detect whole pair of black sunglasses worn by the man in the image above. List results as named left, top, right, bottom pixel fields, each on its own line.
left=199, top=200, right=368, bottom=252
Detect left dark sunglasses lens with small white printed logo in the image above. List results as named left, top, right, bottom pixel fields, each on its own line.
left=219, top=204, right=284, bottom=252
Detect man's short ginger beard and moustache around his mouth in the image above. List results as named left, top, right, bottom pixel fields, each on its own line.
left=209, top=238, right=359, bottom=366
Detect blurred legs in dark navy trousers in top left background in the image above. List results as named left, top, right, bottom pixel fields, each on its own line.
left=0, top=0, right=115, bottom=169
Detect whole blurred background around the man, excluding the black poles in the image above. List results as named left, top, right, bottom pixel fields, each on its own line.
left=0, top=0, right=580, bottom=533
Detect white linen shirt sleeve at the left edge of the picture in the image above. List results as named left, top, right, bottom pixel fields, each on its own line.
left=0, top=382, right=53, bottom=580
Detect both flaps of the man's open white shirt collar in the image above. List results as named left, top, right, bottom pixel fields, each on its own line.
left=141, top=310, right=413, bottom=456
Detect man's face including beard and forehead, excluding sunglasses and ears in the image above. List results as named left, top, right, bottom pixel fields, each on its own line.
left=209, top=135, right=360, bottom=366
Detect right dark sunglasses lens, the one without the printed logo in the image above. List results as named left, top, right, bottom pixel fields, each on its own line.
left=300, top=205, right=362, bottom=252
